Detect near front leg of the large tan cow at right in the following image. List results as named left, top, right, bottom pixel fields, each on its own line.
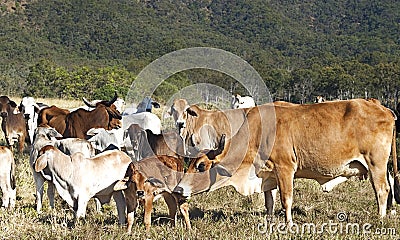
left=276, top=166, right=295, bottom=227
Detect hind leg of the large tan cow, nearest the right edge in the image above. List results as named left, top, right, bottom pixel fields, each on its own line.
left=369, top=164, right=390, bottom=217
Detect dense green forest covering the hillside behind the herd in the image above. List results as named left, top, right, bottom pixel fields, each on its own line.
left=0, top=0, right=400, bottom=107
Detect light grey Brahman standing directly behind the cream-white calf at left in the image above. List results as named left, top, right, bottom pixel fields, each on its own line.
left=29, top=127, right=95, bottom=213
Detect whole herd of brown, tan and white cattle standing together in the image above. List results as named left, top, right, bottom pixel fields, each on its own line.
left=0, top=94, right=400, bottom=232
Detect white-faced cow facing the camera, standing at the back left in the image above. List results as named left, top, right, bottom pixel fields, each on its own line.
left=19, top=97, right=48, bottom=143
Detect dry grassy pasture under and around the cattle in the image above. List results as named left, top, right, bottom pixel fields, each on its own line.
left=0, top=98, right=400, bottom=239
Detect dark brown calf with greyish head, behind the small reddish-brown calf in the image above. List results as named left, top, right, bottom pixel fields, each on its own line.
left=125, top=124, right=184, bottom=161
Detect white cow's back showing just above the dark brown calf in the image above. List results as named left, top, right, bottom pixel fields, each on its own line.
left=122, top=112, right=161, bottom=134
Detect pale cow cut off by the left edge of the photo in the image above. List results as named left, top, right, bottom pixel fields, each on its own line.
left=0, top=146, right=16, bottom=208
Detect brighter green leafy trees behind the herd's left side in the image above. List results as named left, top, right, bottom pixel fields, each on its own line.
left=24, top=60, right=134, bottom=99
